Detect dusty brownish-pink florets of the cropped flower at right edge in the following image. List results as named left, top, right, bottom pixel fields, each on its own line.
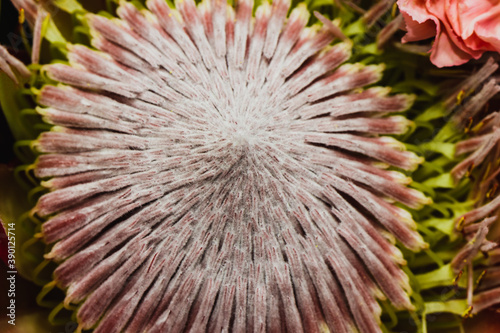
left=451, top=74, right=500, bottom=314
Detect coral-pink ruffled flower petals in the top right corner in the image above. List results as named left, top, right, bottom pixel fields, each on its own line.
left=398, top=0, right=500, bottom=67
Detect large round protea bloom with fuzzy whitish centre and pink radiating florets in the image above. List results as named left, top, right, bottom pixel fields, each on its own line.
left=0, top=0, right=436, bottom=333
